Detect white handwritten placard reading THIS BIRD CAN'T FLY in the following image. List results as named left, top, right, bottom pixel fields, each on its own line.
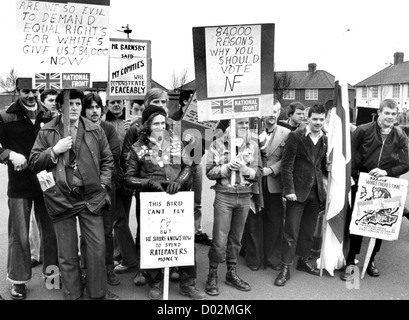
left=140, top=191, right=194, bottom=269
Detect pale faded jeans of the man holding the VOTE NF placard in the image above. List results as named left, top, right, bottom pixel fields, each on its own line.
left=208, top=191, right=250, bottom=267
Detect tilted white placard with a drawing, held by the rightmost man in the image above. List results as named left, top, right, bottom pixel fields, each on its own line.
left=349, top=173, right=408, bottom=240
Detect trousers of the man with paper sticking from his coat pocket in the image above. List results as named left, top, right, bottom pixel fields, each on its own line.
left=54, top=205, right=107, bottom=300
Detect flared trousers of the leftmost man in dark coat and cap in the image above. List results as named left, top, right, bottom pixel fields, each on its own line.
left=7, top=195, right=58, bottom=283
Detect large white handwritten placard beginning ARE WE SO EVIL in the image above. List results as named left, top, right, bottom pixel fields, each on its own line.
left=16, top=0, right=109, bottom=81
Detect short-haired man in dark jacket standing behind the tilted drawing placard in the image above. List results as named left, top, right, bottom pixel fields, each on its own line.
left=340, top=99, right=409, bottom=281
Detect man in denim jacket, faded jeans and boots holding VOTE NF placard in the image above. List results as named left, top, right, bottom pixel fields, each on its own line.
left=205, top=118, right=262, bottom=296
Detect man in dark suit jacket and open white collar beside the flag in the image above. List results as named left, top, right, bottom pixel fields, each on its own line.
left=274, top=105, right=328, bottom=286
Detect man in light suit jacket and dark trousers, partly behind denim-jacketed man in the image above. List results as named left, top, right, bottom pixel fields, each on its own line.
left=242, top=100, right=291, bottom=271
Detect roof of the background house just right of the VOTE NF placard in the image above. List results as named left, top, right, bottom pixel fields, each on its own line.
left=276, top=70, right=353, bottom=90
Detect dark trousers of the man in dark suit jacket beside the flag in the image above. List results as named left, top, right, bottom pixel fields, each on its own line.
left=281, top=188, right=321, bottom=265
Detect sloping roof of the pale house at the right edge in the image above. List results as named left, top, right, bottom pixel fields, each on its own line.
left=355, top=61, right=409, bottom=87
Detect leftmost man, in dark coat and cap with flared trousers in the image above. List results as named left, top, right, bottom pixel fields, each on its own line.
left=0, top=78, right=58, bottom=300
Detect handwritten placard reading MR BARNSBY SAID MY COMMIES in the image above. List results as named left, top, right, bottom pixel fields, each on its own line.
left=108, top=39, right=151, bottom=99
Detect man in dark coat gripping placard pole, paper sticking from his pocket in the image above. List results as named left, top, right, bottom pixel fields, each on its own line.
left=29, top=90, right=119, bottom=300
